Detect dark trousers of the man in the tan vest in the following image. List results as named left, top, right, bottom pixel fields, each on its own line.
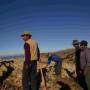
left=22, top=60, right=37, bottom=90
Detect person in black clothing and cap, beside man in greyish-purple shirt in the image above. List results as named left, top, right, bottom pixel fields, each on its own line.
left=73, top=40, right=87, bottom=90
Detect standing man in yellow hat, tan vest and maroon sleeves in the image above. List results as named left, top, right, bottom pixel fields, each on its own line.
left=21, top=32, right=40, bottom=90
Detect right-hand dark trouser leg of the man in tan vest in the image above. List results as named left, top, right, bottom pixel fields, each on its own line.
left=30, top=61, right=37, bottom=90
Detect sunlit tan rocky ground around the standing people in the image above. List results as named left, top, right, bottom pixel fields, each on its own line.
left=0, top=50, right=82, bottom=90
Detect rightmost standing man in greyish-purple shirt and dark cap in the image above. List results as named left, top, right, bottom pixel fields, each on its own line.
left=80, top=40, right=90, bottom=90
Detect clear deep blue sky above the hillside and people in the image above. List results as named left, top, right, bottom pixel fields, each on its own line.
left=0, top=0, right=90, bottom=54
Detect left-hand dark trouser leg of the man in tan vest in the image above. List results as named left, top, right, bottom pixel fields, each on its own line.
left=22, top=65, right=30, bottom=90
